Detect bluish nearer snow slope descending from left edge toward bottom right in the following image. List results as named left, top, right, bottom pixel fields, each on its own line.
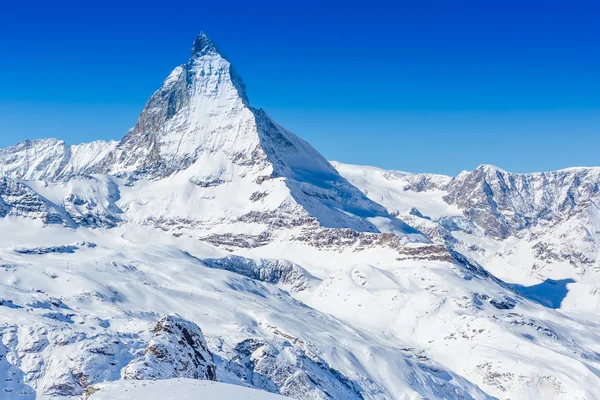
left=0, top=219, right=488, bottom=399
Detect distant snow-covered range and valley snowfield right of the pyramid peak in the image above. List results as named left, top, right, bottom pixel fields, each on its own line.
left=333, top=162, right=600, bottom=311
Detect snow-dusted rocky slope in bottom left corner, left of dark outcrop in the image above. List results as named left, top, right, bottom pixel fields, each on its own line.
left=0, top=308, right=137, bottom=400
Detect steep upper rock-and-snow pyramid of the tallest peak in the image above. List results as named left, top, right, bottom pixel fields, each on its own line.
left=107, top=34, right=253, bottom=178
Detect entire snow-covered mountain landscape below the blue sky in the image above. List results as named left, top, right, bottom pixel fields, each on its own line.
left=0, top=34, right=600, bottom=399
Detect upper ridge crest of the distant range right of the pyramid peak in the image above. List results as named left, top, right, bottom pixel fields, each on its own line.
left=335, top=163, right=600, bottom=239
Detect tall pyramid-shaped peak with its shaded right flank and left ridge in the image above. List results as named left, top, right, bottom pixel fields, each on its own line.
left=0, top=34, right=426, bottom=241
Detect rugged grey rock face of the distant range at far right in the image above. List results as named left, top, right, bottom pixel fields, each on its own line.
left=444, top=165, right=600, bottom=238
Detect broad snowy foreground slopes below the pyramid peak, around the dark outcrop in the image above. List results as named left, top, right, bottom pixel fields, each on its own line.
left=0, top=218, right=600, bottom=399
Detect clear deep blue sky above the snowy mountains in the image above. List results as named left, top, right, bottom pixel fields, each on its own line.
left=0, top=0, right=600, bottom=174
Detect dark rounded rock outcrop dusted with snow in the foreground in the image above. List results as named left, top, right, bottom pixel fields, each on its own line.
left=122, top=315, right=217, bottom=381
